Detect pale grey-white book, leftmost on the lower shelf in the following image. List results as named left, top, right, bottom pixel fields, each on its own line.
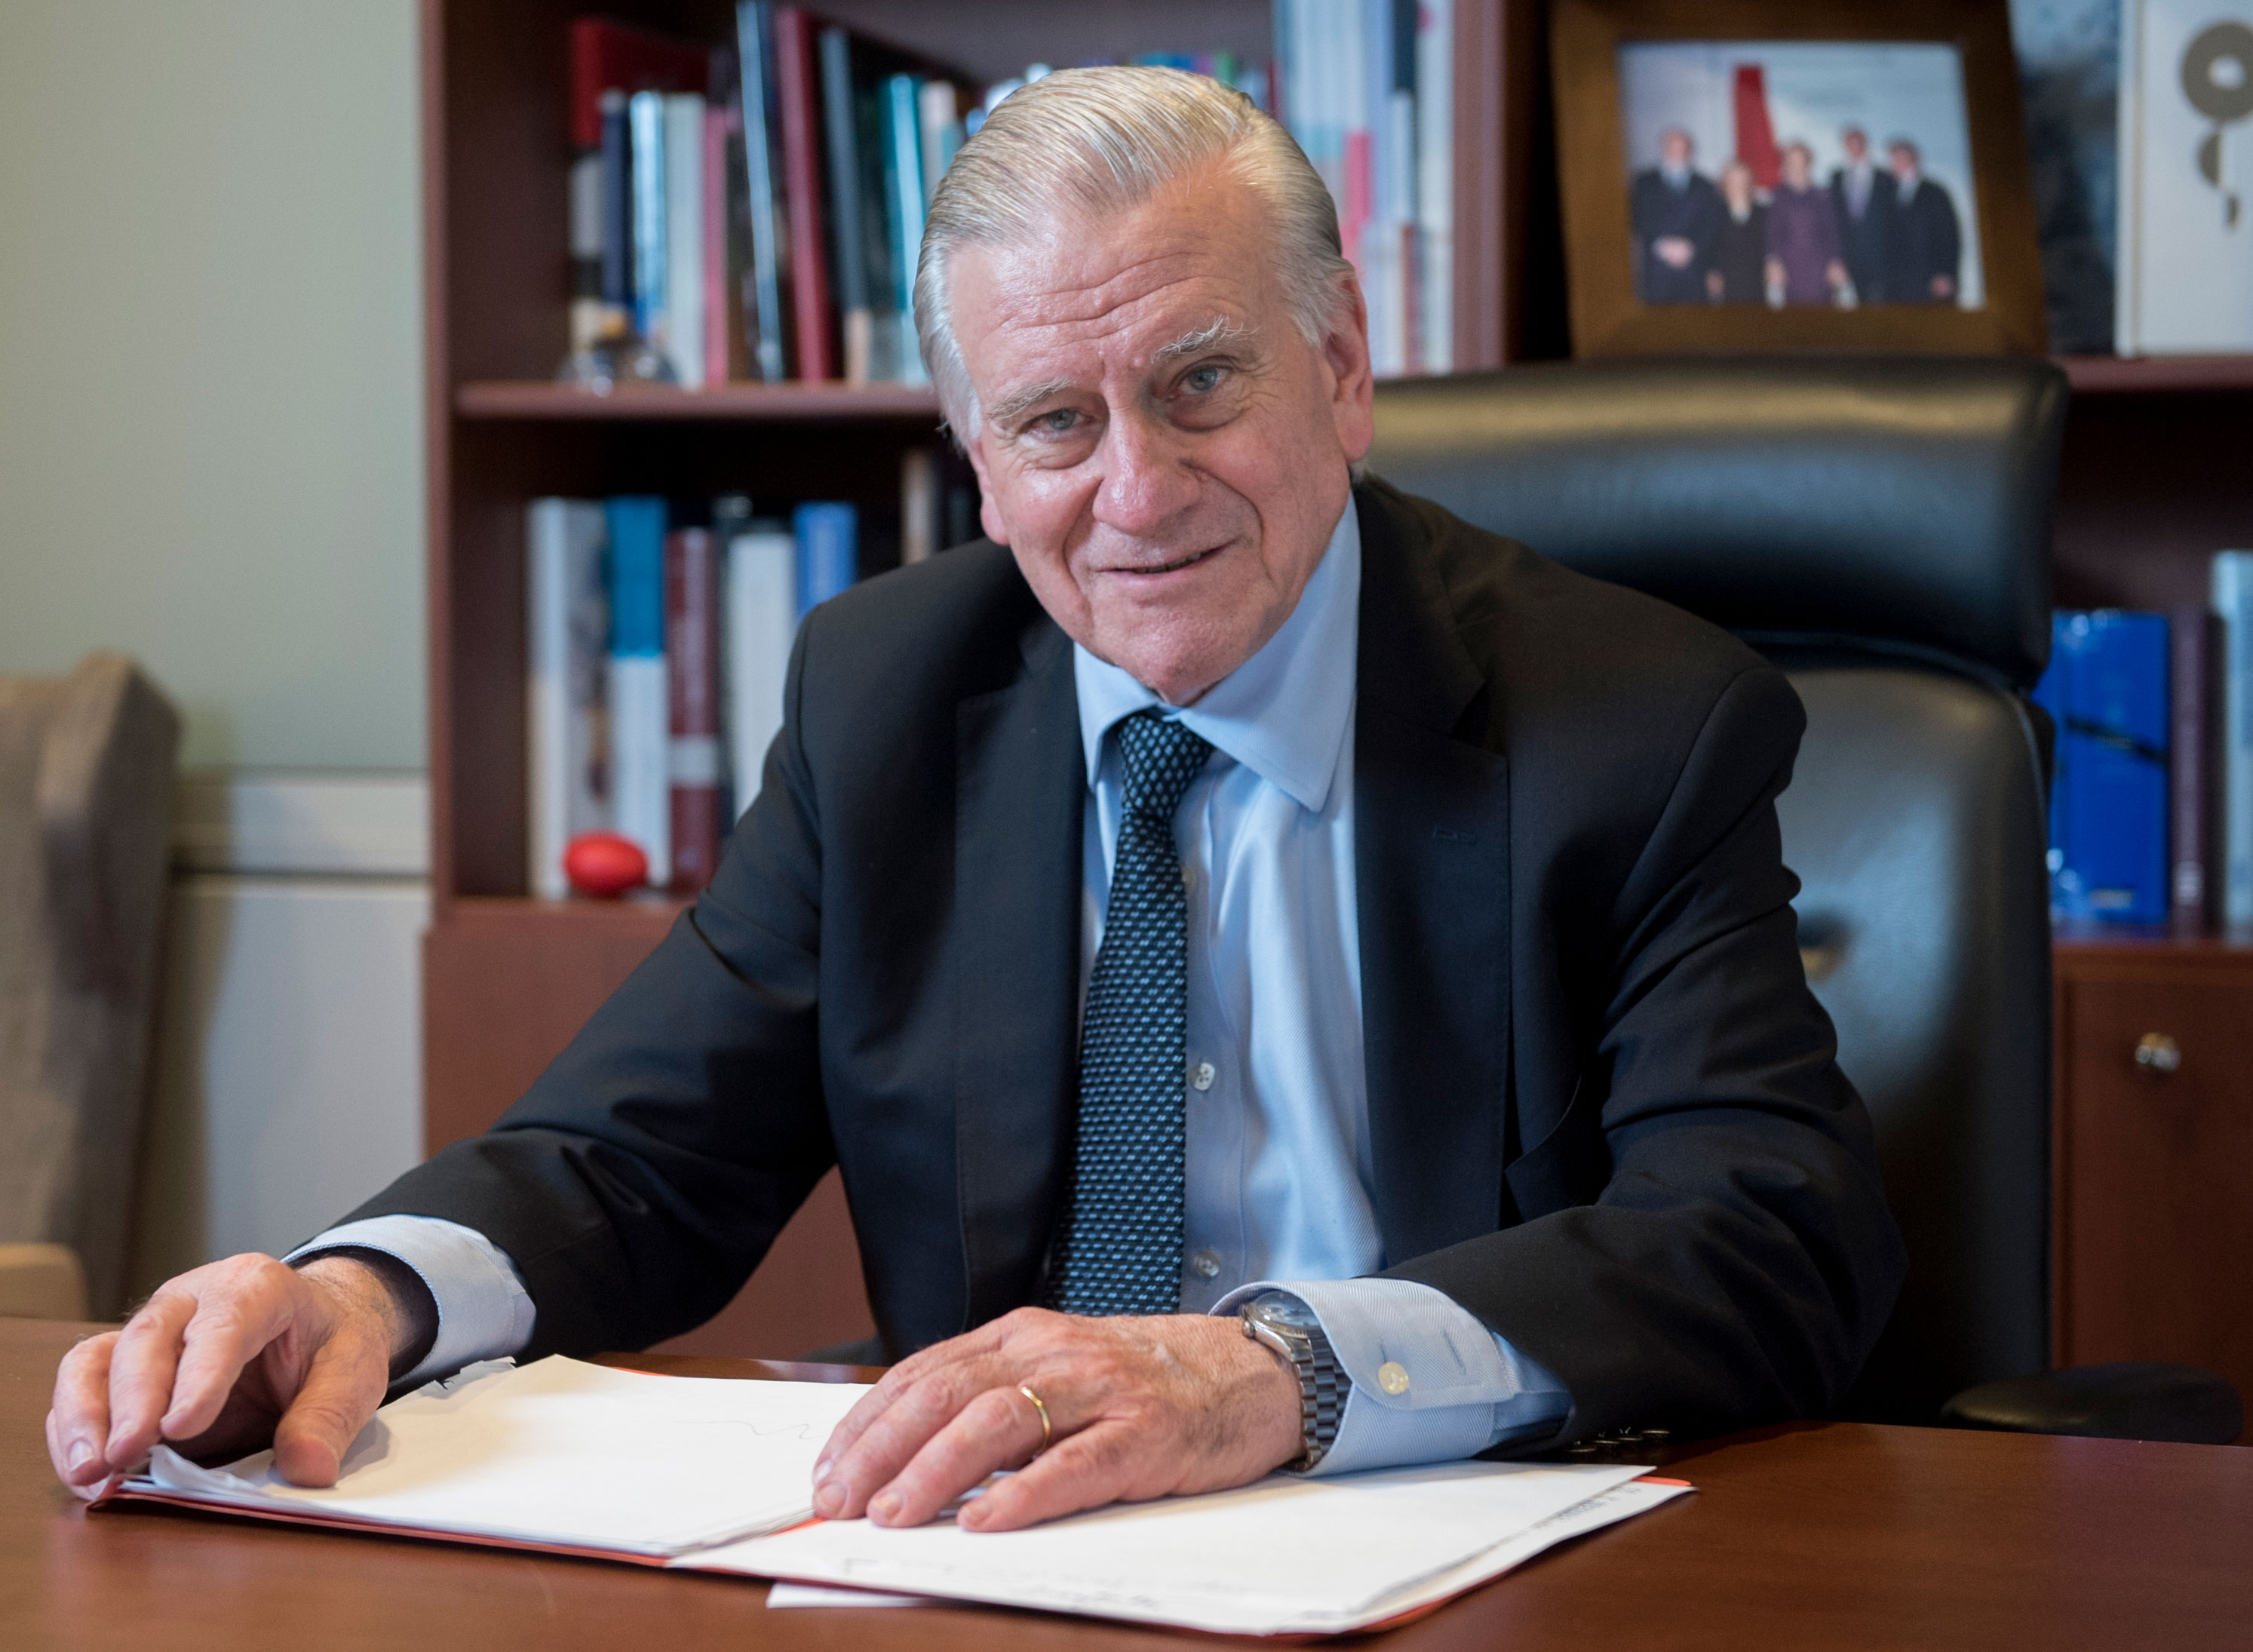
left=525, top=498, right=610, bottom=899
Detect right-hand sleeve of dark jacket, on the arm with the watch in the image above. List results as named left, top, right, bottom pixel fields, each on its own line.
left=1390, top=665, right=1904, bottom=1445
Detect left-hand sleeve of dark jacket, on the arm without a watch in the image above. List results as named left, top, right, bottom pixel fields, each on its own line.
left=349, top=618, right=836, bottom=1359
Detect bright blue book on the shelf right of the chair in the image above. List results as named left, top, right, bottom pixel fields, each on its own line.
left=2037, top=609, right=2172, bottom=924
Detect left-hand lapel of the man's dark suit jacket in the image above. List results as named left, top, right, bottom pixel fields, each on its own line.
left=955, top=620, right=1088, bottom=1330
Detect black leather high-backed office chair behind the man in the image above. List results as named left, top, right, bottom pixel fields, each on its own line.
left=1370, top=358, right=2239, bottom=1442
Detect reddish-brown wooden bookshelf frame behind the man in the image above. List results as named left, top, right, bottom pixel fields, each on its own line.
left=422, top=0, right=2253, bottom=1357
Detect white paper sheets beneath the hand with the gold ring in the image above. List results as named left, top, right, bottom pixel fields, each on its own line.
left=693, top=1463, right=1683, bottom=1634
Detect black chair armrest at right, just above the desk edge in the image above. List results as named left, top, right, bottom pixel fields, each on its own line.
left=1940, top=1359, right=2244, bottom=1445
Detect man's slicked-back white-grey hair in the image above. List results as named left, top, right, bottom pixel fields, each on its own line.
left=915, top=68, right=1354, bottom=440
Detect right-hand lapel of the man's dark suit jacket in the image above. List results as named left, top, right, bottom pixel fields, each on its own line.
left=1354, top=487, right=1509, bottom=1264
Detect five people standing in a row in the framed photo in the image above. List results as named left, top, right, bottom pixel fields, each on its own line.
left=1629, top=126, right=1963, bottom=309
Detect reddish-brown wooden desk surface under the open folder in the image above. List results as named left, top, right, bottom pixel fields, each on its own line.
left=0, top=1321, right=2253, bottom=1652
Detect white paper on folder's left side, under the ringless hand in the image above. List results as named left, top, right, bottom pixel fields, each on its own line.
left=140, top=1357, right=867, bottom=1558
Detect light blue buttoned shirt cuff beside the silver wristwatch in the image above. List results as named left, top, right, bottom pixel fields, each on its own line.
left=1212, top=1278, right=1573, bottom=1474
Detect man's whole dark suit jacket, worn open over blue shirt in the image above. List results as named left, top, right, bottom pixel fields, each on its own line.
left=354, top=482, right=1902, bottom=1436
